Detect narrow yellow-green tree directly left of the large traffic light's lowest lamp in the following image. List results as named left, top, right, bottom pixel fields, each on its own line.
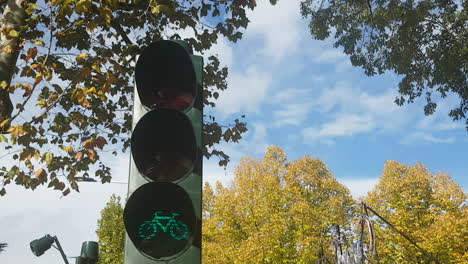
left=96, top=194, right=125, bottom=264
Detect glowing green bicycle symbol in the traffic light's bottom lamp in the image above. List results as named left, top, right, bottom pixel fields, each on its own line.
left=138, top=211, right=189, bottom=240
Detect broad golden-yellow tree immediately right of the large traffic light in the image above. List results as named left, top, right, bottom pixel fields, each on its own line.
left=202, top=146, right=353, bottom=264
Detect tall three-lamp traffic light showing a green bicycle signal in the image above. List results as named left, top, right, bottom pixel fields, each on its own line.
left=123, top=40, right=203, bottom=264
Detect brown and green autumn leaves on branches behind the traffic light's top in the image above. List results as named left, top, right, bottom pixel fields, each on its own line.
left=0, top=0, right=276, bottom=195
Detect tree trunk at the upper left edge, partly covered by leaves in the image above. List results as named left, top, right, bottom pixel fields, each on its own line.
left=0, top=0, right=26, bottom=133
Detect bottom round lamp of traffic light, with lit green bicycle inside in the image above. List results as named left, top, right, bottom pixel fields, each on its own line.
left=123, top=182, right=197, bottom=259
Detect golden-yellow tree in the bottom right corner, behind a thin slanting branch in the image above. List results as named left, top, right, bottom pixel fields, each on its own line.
left=365, top=161, right=468, bottom=264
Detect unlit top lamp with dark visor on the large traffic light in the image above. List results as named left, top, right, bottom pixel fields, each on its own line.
left=135, top=40, right=197, bottom=110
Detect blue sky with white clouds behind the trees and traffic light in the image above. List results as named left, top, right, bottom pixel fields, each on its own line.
left=0, top=0, right=468, bottom=264
